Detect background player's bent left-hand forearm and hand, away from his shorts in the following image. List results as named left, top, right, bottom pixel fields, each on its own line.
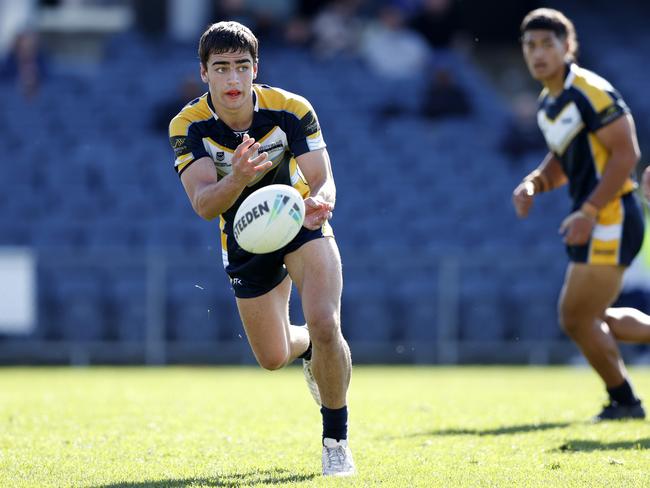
left=512, top=152, right=568, bottom=219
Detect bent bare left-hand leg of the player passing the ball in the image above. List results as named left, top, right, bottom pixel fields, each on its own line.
left=237, top=276, right=309, bottom=370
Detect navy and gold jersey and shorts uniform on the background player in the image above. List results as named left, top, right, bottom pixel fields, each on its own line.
left=537, top=64, right=643, bottom=266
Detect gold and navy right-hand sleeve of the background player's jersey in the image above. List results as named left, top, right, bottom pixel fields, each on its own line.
left=580, top=85, right=630, bottom=132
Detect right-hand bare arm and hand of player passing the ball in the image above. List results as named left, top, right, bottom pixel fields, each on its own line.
left=296, top=148, right=336, bottom=230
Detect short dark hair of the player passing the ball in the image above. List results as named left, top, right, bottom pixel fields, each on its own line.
left=199, top=21, right=258, bottom=66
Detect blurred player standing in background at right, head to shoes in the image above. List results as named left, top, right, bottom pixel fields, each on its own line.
left=513, top=8, right=648, bottom=421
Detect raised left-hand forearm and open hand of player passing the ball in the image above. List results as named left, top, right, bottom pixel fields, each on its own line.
left=181, top=134, right=273, bottom=220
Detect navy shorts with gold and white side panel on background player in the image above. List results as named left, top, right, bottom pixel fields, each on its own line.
left=566, top=193, right=644, bottom=266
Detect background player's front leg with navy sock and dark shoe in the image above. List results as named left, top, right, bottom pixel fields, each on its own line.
left=559, top=263, right=645, bottom=421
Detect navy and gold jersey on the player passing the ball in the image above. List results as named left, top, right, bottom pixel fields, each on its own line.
left=169, top=84, right=325, bottom=235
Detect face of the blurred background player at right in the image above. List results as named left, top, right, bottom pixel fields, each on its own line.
left=522, top=30, right=568, bottom=82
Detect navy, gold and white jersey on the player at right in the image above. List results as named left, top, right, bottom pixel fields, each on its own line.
left=537, top=64, right=636, bottom=209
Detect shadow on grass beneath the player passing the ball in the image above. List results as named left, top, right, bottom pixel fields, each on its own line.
left=89, top=469, right=320, bottom=488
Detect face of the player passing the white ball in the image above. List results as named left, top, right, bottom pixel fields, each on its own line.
left=201, top=51, right=257, bottom=112
